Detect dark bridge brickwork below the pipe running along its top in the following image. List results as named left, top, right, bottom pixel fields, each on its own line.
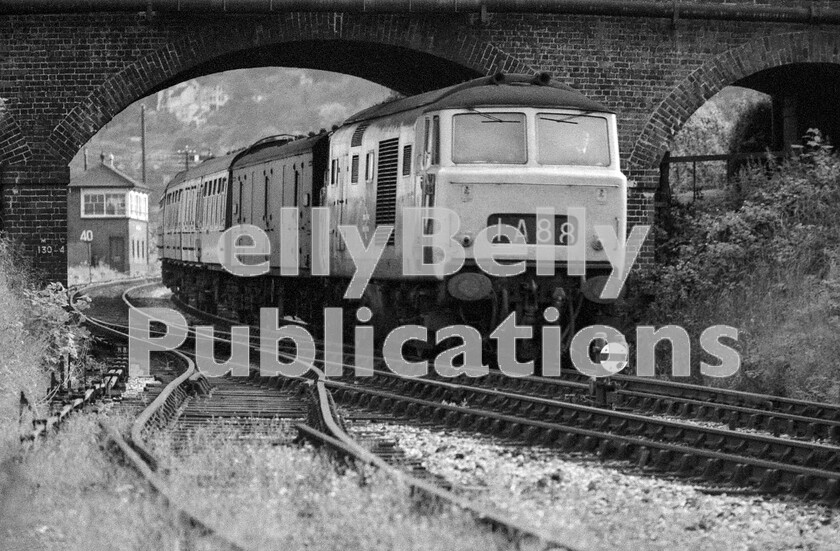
left=0, top=0, right=840, bottom=278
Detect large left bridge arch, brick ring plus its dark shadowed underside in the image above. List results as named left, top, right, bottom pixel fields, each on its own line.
left=48, top=14, right=536, bottom=163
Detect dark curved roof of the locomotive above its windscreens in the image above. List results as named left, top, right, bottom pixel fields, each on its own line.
left=344, top=73, right=613, bottom=125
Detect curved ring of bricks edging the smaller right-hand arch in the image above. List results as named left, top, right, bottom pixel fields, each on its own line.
left=628, top=31, right=840, bottom=170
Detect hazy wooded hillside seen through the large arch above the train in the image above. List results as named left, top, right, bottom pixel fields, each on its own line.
left=70, top=67, right=391, bottom=203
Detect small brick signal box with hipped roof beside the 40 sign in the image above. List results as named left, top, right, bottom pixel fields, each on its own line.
left=67, top=154, right=149, bottom=273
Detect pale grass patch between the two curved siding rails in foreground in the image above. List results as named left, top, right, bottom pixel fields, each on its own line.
left=146, top=425, right=495, bottom=550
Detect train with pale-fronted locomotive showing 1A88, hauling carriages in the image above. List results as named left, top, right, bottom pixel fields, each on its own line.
left=158, top=73, right=627, bottom=358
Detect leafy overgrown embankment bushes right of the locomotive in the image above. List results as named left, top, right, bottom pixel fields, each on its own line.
left=628, top=130, right=840, bottom=401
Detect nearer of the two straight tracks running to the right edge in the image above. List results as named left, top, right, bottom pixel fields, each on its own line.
left=326, top=373, right=840, bottom=506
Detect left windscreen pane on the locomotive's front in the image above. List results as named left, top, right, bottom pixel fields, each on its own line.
left=452, top=112, right=528, bottom=164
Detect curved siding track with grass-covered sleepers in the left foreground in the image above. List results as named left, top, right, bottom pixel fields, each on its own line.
left=77, top=286, right=569, bottom=549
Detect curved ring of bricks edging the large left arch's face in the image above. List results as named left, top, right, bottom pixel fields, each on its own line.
left=47, top=14, right=536, bottom=163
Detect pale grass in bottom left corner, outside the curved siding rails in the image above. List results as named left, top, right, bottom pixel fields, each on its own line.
left=0, top=413, right=221, bottom=551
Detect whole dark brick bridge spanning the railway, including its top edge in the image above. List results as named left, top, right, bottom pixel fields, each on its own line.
left=0, top=0, right=840, bottom=281
